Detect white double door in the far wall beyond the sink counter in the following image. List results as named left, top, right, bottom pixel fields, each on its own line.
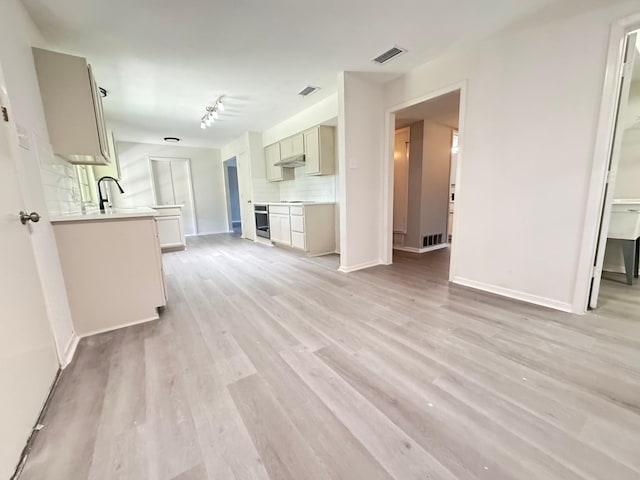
left=149, top=157, right=198, bottom=235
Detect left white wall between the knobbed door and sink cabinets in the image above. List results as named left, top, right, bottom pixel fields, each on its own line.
left=0, top=0, right=80, bottom=365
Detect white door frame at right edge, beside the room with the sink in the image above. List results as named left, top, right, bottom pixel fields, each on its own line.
left=572, top=13, right=640, bottom=313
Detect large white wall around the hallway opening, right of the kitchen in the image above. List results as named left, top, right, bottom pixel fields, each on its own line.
left=341, top=2, right=640, bottom=311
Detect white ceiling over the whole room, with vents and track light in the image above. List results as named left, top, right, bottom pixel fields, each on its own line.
left=23, top=0, right=554, bottom=147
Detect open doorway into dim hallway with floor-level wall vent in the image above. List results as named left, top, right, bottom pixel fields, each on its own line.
left=392, top=89, right=461, bottom=278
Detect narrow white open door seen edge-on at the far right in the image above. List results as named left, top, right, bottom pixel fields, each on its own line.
left=589, top=33, right=638, bottom=308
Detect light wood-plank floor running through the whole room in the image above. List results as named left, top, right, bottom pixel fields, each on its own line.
left=17, top=235, right=640, bottom=480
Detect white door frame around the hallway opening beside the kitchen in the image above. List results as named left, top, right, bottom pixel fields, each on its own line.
left=381, top=80, right=467, bottom=281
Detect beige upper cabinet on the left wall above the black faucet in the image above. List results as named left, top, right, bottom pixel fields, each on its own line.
left=33, top=48, right=110, bottom=165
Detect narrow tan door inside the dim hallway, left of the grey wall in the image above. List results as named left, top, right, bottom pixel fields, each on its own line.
left=393, top=127, right=411, bottom=233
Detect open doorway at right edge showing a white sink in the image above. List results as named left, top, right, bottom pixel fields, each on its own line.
left=589, top=31, right=640, bottom=319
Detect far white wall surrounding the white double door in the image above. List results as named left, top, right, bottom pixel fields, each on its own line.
left=116, top=142, right=229, bottom=234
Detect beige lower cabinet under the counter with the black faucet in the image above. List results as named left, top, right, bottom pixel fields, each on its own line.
left=52, top=214, right=166, bottom=336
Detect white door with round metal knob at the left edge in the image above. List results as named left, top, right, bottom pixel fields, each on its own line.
left=0, top=64, right=58, bottom=478
